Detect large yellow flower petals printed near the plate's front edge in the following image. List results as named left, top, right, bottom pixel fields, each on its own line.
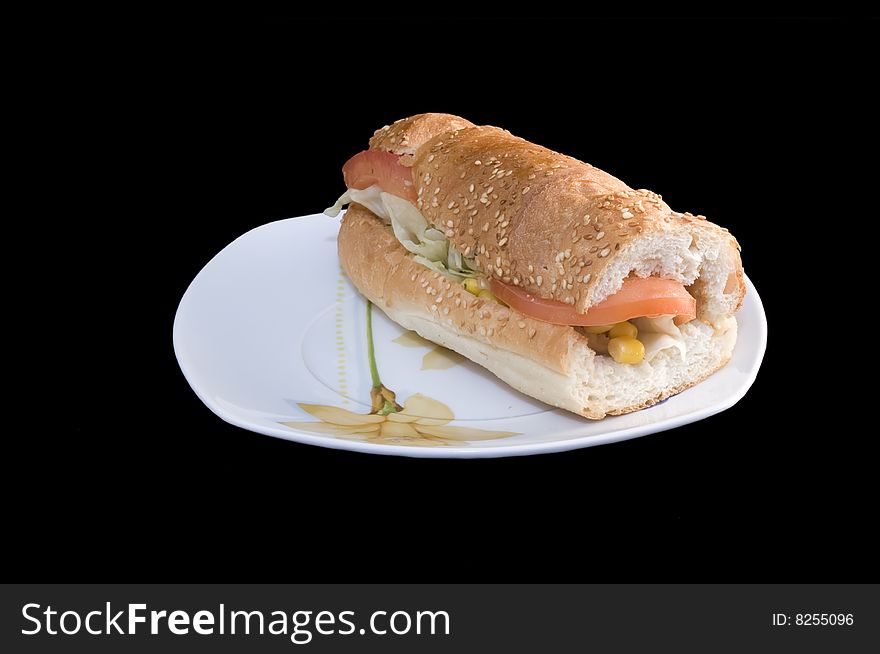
left=281, top=393, right=517, bottom=447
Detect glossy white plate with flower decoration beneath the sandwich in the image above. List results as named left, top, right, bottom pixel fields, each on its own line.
left=174, top=215, right=767, bottom=457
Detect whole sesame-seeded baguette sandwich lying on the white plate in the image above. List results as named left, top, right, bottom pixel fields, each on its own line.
left=327, top=114, right=745, bottom=419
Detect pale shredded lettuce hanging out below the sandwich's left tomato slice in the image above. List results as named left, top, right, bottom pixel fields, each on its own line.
left=324, top=184, right=480, bottom=278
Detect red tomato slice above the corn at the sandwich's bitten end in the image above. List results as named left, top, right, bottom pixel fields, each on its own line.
left=490, top=277, right=697, bottom=326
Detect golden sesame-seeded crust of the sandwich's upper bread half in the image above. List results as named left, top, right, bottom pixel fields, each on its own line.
left=370, top=114, right=745, bottom=313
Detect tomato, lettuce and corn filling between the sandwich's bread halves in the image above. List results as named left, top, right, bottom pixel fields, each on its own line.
left=324, top=150, right=696, bottom=364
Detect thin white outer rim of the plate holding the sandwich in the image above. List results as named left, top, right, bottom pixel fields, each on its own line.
left=172, top=214, right=767, bottom=459
